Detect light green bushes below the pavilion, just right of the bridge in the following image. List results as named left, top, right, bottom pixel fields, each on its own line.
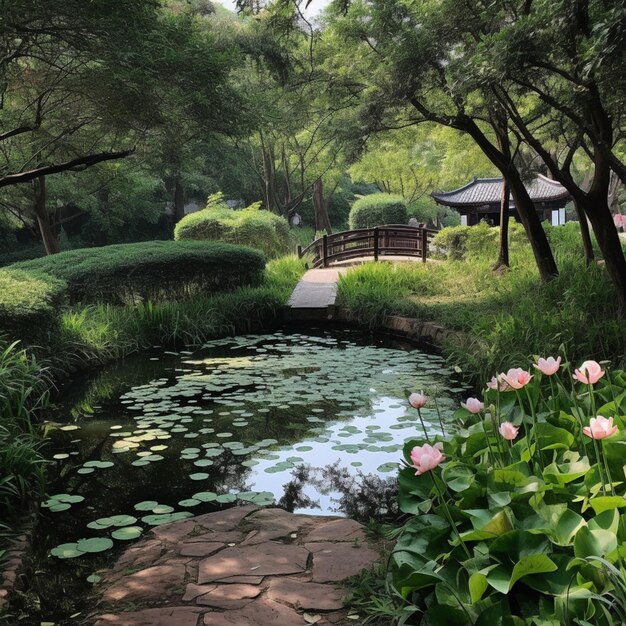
left=432, top=221, right=528, bottom=261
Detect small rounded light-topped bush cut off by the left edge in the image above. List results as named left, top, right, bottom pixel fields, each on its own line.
left=0, top=268, right=66, bottom=343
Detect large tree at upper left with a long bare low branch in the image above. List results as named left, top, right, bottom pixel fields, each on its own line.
left=0, top=0, right=243, bottom=253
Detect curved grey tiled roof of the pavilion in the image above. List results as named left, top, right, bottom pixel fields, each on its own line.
left=430, top=174, right=570, bottom=207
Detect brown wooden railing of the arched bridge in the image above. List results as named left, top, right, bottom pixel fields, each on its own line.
left=298, top=224, right=437, bottom=267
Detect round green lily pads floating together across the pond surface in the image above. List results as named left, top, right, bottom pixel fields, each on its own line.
left=48, top=333, right=461, bottom=558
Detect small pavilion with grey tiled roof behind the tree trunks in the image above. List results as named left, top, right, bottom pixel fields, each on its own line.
left=431, top=174, right=571, bottom=226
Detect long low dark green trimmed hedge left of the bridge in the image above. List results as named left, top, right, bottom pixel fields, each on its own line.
left=10, top=241, right=265, bottom=304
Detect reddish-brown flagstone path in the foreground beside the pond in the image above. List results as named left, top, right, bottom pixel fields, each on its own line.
left=95, top=506, right=379, bottom=626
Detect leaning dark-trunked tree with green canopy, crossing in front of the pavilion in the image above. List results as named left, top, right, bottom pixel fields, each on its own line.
left=320, top=0, right=558, bottom=280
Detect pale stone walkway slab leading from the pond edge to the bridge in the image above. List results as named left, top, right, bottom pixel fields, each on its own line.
left=287, top=268, right=346, bottom=319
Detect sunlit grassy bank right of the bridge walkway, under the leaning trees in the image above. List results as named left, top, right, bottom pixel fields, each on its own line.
left=339, top=222, right=626, bottom=381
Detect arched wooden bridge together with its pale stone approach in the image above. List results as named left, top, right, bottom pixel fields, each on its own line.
left=285, top=224, right=437, bottom=321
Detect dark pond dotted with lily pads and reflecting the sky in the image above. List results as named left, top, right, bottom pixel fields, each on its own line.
left=14, top=330, right=465, bottom=620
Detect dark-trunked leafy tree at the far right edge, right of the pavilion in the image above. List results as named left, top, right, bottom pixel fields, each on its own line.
left=466, top=0, right=626, bottom=312
